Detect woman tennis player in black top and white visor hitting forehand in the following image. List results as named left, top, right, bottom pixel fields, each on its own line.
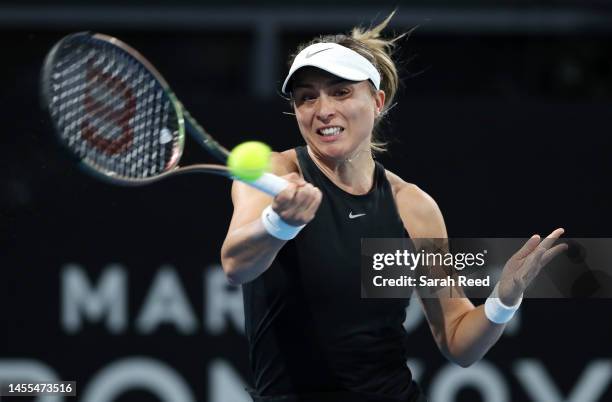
left=221, top=15, right=563, bottom=402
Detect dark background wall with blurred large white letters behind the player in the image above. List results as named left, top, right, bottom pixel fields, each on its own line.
left=0, top=1, right=612, bottom=402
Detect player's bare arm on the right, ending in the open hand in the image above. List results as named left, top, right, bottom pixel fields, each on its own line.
left=390, top=175, right=566, bottom=367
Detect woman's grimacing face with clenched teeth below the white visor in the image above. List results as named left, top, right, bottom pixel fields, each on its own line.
left=292, top=67, right=385, bottom=160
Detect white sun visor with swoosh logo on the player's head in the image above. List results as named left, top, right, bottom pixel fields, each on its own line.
left=282, top=43, right=380, bottom=95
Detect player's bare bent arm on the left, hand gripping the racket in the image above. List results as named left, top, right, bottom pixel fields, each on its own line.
left=221, top=153, right=321, bottom=285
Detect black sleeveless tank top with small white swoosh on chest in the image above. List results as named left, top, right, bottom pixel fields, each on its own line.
left=243, top=147, right=424, bottom=402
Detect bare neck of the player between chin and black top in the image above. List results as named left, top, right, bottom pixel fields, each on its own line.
left=307, top=146, right=375, bottom=195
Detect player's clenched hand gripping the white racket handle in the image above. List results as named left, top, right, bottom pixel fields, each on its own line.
left=272, top=173, right=323, bottom=226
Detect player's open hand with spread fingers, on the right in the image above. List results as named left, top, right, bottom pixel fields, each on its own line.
left=498, top=228, right=567, bottom=306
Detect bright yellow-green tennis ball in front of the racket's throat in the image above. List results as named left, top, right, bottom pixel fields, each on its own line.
left=227, top=141, right=272, bottom=182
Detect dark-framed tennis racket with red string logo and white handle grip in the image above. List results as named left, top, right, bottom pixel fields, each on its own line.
left=41, top=32, right=288, bottom=196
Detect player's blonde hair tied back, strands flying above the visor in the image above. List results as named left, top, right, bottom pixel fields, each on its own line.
left=289, top=10, right=406, bottom=152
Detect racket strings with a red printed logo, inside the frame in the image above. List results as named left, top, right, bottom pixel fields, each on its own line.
left=51, top=38, right=182, bottom=178
